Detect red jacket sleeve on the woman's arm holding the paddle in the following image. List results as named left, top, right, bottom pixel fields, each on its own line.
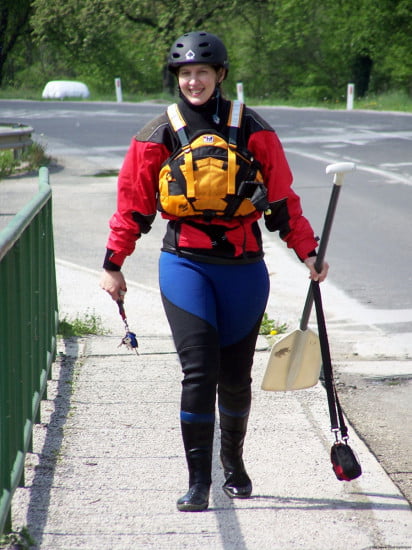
left=248, top=130, right=318, bottom=260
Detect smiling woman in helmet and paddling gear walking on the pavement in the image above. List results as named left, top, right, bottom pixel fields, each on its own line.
left=101, top=31, right=328, bottom=511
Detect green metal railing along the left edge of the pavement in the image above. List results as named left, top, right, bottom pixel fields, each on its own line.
left=0, top=168, right=58, bottom=534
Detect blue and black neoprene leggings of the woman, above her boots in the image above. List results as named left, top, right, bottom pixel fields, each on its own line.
left=159, top=252, right=269, bottom=422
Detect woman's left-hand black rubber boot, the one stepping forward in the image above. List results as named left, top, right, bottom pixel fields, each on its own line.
left=176, top=422, right=214, bottom=512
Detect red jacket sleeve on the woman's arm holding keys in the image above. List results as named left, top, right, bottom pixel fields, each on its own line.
left=107, top=139, right=170, bottom=266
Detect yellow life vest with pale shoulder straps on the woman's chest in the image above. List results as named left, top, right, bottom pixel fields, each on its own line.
left=158, top=101, right=268, bottom=219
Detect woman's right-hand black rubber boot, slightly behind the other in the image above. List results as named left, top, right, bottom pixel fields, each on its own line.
left=220, top=412, right=252, bottom=498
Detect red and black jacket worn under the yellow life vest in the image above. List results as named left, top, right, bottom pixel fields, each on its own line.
left=104, top=98, right=317, bottom=270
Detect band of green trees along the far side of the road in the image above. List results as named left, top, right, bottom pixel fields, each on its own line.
left=4, top=0, right=412, bottom=100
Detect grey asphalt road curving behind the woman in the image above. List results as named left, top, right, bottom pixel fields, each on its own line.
left=0, top=101, right=412, bottom=314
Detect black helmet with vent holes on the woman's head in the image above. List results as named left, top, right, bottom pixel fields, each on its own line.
left=167, top=31, right=229, bottom=73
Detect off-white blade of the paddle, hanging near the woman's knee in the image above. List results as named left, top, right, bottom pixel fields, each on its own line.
left=261, top=329, right=322, bottom=391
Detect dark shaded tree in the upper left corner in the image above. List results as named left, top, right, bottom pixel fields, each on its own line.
left=0, top=0, right=32, bottom=86
